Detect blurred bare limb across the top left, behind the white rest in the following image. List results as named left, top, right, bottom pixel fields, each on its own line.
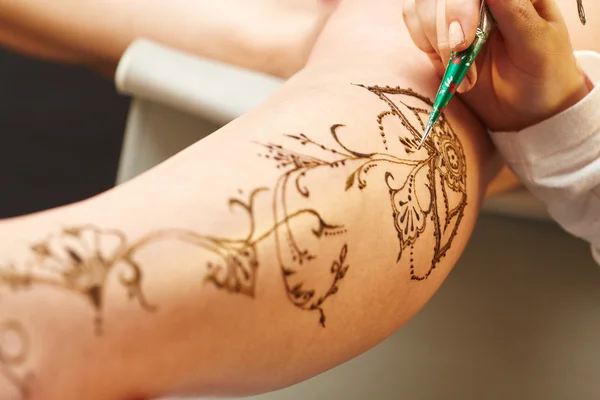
left=0, top=0, right=334, bottom=77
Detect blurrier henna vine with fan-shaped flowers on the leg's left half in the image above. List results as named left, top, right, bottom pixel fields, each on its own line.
left=0, top=198, right=348, bottom=398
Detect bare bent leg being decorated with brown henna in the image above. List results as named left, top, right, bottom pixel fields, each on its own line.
left=0, top=57, right=493, bottom=400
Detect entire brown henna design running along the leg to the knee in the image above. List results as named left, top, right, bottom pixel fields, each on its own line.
left=0, top=85, right=467, bottom=394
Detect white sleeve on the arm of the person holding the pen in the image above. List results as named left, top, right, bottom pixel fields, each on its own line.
left=490, top=51, right=600, bottom=264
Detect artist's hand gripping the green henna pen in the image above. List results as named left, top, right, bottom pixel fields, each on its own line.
left=404, top=0, right=589, bottom=131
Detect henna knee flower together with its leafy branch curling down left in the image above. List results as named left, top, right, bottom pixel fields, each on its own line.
left=264, top=85, right=467, bottom=282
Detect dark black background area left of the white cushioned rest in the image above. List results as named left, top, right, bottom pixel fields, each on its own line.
left=0, top=49, right=129, bottom=218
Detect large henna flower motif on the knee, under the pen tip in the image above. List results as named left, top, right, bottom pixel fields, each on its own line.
left=359, top=85, right=467, bottom=280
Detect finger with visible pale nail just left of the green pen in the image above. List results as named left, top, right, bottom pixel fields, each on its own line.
left=445, top=0, right=482, bottom=51
